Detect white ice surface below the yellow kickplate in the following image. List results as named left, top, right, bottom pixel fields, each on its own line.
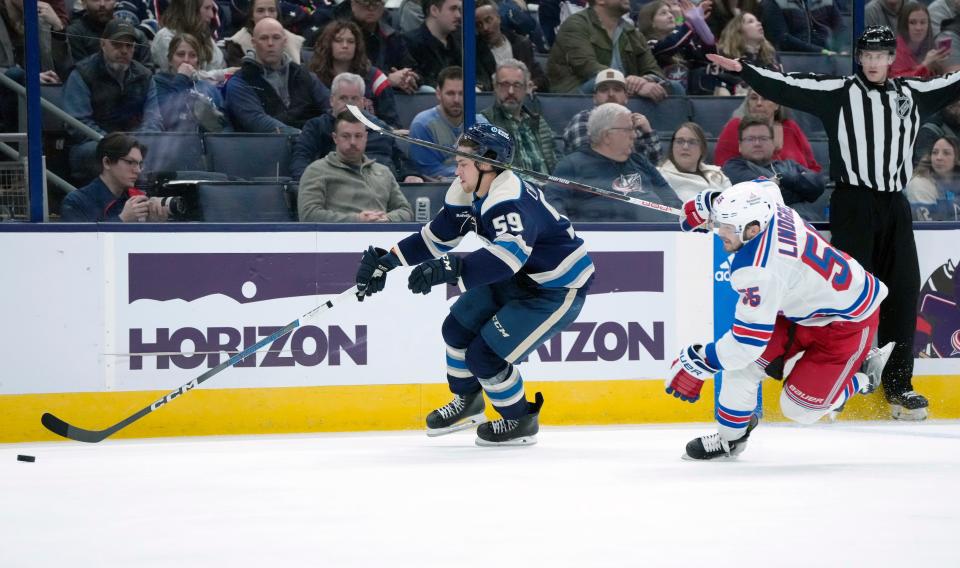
left=0, top=422, right=960, bottom=568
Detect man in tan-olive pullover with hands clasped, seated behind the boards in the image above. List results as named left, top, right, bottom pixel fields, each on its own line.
left=297, top=112, right=413, bottom=223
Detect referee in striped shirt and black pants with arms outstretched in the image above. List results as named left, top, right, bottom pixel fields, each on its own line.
left=707, top=26, right=960, bottom=420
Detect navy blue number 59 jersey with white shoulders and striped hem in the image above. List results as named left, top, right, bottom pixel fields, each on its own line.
left=396, top=170, right=594, bottom=290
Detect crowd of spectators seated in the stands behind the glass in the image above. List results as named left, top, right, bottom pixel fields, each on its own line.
left=0, top=0, right=960, bottom=221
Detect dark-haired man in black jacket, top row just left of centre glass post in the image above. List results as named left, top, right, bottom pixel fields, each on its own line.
left=403, top=0, right=463, bottom=89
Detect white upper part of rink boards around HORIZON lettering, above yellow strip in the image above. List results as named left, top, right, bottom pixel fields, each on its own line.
left=0, top=231, right=713, bottom=394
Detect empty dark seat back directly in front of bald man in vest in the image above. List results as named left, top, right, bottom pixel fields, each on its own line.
left=203, top=133, right=292, bottom=179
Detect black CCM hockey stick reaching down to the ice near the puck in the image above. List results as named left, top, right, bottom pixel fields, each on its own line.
left=40, top=286, right=357, bottom=444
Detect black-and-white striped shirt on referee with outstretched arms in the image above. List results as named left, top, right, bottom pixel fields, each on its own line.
left=741, top=61, right=960, bottom=191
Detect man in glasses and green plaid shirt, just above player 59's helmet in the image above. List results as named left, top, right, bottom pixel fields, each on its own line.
left=480, top=59, right=557, bottom=174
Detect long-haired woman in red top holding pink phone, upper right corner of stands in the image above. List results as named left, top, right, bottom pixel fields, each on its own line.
left=890, top=2, right=950, bottom=78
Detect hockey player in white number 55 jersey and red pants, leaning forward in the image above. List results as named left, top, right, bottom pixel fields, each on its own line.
left=666, top=180, right=892, bottom=460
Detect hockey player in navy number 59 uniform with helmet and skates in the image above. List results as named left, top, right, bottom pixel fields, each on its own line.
left=357, top=124, right=594, bottom=446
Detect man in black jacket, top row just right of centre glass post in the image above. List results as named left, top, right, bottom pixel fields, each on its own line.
left=476, top=0, right=550, bottom=93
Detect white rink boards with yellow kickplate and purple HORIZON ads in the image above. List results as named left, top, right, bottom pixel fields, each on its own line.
left=0, top=225, right=960, bottom=442
